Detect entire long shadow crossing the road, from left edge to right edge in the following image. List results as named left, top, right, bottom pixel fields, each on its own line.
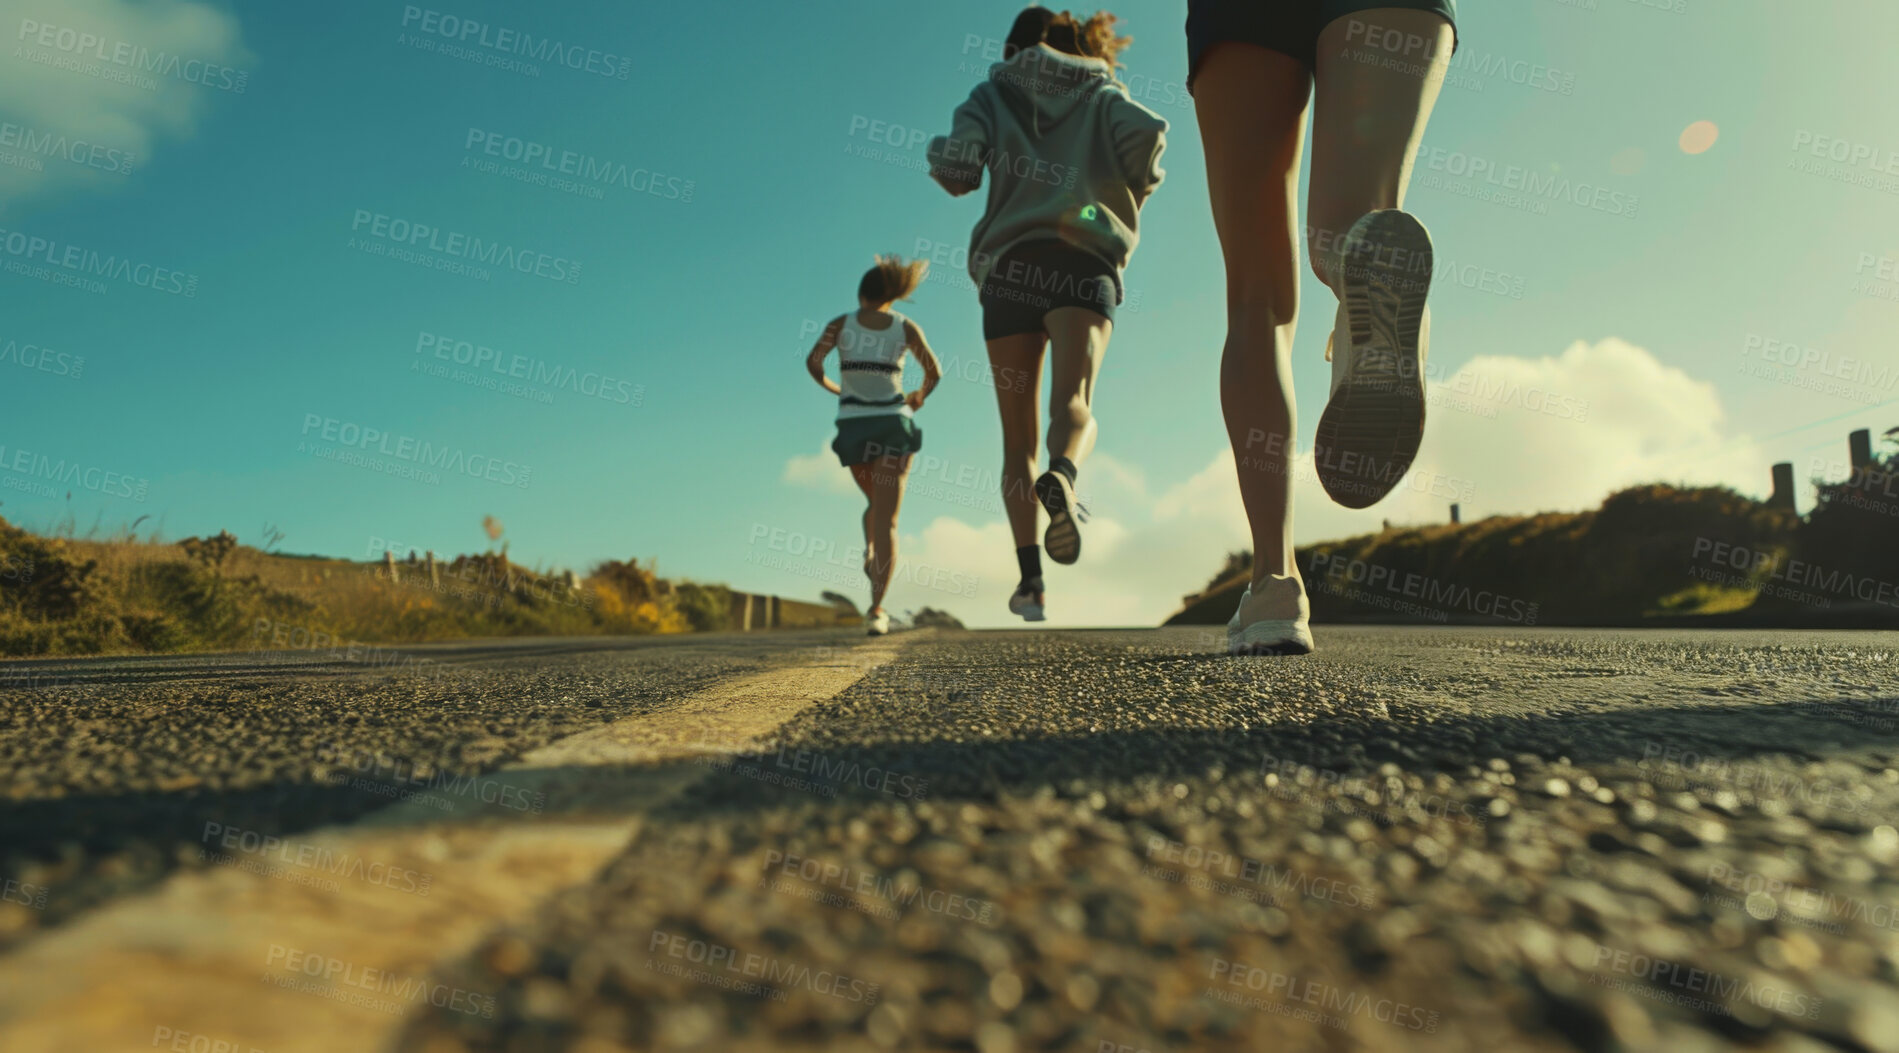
left=11, top=694, right=1899, bottom=948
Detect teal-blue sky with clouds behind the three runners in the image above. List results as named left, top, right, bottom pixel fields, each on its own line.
left=0, top=0, right=1899, bottom=624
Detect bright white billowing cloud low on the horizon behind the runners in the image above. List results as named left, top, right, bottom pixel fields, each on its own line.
left=881, top=338, right=1768, bottom=626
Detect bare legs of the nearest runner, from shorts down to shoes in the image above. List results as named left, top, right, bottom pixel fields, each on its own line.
left=1194, top=8, right=1453, bottom=584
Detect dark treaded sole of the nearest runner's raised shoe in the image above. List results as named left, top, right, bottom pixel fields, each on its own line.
left=1312, top=209, right=1434, bottom=508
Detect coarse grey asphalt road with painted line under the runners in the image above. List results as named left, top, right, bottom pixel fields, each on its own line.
left=0, top=628, right=1899, bottom=1053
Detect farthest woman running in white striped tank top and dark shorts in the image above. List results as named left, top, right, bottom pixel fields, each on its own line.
left=805, top=256, right=944, bottom=636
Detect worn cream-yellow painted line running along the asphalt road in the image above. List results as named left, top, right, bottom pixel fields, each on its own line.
left=0, top=637, right=902, bottom=1053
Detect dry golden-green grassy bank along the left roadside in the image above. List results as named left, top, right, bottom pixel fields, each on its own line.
left=0, top=520, right=748, bottom=656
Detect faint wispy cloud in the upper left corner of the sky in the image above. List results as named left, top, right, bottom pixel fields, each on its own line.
left=0, top=0, right=254, bottom=201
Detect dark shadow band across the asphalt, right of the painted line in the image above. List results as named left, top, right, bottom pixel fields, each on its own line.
left=653, top=694, right=1899, bottom=820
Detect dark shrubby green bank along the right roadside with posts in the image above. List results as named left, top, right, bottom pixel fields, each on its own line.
left=1168, top=455, right=1899, bottom=628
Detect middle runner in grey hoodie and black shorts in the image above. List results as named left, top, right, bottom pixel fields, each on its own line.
left=929, top=8, right=1168, bottom=620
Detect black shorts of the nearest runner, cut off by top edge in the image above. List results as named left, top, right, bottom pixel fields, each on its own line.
left=1187, top=0, right=1457, bottom=93
